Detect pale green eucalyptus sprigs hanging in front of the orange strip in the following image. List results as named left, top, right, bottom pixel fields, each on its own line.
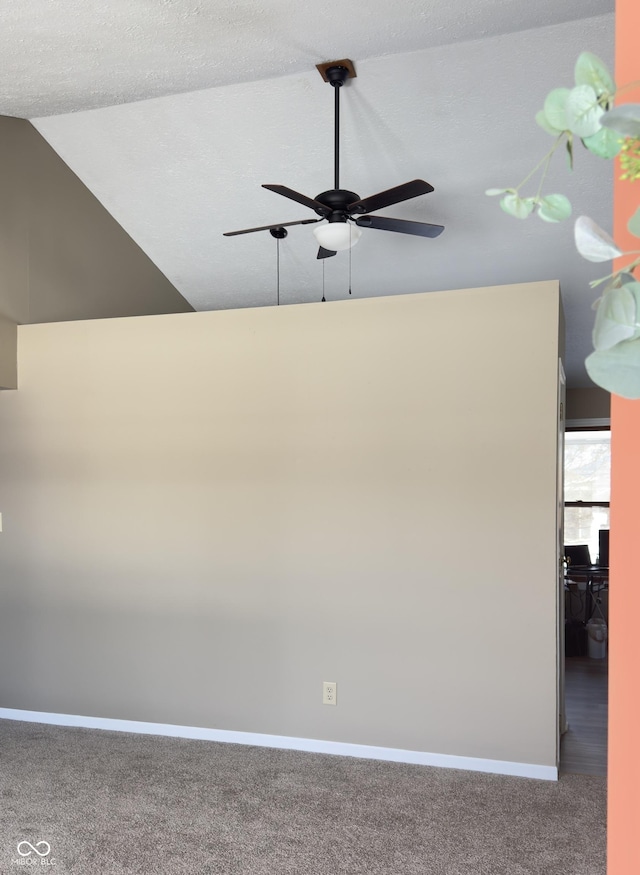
left=486, top=52, right=640, bottom=398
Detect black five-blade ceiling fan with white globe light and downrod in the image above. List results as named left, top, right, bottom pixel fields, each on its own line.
left=224, top=60, right=444, bottom=258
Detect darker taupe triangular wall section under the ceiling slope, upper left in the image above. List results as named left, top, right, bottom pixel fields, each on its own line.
left=0, top=116, right=192, bottom=323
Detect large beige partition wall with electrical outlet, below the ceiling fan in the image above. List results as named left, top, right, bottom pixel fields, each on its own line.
left=0, top=283, right=559, bottom=765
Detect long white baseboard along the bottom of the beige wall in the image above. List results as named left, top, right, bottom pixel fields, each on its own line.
left=0, top=708, right=558, bottom=781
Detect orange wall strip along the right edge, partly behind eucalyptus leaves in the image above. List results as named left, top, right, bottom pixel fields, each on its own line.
left=607, top=0, right=640, bottom=875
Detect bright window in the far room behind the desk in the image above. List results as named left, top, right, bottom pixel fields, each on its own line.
left=564, top=430, right=611, bottom=562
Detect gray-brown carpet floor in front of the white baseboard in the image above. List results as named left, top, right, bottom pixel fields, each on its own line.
left=0, top=720, right=606, bottom=875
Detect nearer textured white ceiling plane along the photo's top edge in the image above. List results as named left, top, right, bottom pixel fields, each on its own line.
left=0, top=0, right=613, bottom=118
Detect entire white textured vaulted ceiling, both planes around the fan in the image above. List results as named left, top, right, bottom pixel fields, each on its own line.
left=0, top=0, right=613, bottom=386
